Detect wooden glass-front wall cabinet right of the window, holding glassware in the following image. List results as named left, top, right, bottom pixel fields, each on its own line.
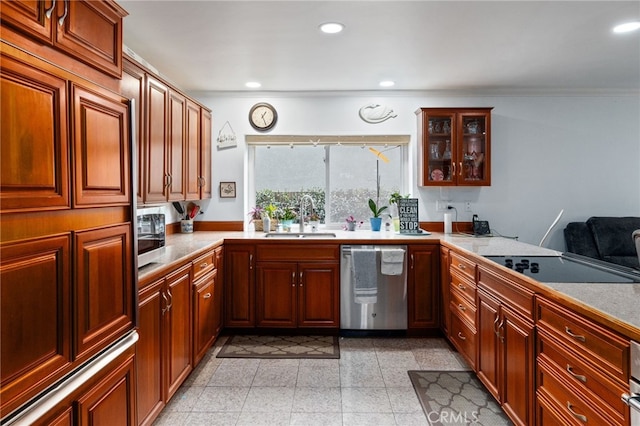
left=416, top=108, right=493, bottom=186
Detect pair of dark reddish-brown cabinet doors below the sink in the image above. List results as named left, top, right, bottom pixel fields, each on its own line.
left=256, top=262, right=340, bottom=328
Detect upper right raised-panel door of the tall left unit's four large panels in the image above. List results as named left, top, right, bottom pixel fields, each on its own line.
left=72, top=85, right=131, bottom=207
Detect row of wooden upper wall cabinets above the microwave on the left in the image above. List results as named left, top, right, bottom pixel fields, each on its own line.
left=120, top=57, right=211, bottom=204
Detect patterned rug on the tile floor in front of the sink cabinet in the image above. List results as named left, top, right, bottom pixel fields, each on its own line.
left=217, top=335, right=340, bottom=359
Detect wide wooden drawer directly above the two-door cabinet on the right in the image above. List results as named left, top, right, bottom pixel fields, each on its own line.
left=478, top=267, right=534, bottom=320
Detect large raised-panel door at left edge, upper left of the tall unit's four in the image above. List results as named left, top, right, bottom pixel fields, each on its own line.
left=0, top=52, right=71, bottom=212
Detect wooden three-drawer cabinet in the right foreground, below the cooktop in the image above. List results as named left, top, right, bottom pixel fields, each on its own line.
left=536, top=296, right=631, bottom=425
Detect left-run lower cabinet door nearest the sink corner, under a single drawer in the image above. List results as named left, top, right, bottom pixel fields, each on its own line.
left=193, top=270, right=217, bottom=366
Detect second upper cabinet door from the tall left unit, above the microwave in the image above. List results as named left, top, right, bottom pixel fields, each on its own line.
left=143, top=75, right=169, bottom=203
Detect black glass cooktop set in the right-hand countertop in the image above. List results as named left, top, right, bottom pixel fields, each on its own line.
left=485, top=253, right=640, bottom=283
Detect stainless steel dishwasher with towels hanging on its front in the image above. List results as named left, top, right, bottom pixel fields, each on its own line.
left=340, top=245, right=407, bottom=330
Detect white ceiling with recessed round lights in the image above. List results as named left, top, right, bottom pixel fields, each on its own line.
left=118, top=0, right=640, bottom=92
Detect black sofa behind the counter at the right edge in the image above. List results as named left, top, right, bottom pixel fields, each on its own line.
left=564, top=216, right=640, bottom=269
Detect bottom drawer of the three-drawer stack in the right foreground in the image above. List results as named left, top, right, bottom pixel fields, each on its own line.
left=538, top=363, right=624, bottom=425
